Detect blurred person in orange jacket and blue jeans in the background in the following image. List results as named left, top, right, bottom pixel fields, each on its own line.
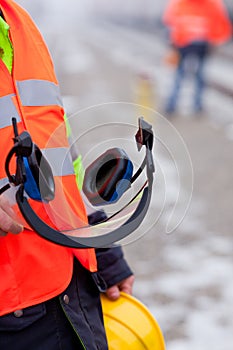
left=163, top=0, right=232, bottom=114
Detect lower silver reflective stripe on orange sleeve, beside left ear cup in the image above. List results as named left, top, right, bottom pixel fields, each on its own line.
left=42, top=147, right=74, bottom=176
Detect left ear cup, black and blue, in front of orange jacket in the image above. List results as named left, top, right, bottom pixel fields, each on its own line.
left=24, top=144, right=55, bottom=202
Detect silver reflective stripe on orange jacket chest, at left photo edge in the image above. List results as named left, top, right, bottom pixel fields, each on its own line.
left=0, top=94, right=20, bottom=128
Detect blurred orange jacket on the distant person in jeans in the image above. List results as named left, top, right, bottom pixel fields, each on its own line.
left=163, top=0, right=232, bottom=47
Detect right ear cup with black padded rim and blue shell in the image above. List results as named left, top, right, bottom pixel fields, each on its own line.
left=83, top=148, right=133, bottom=206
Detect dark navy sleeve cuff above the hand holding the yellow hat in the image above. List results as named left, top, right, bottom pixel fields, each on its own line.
left=96, top=246, right=133, bottom=288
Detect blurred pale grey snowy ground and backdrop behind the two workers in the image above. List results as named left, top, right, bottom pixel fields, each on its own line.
left=18, top=0, right=233, bottom=350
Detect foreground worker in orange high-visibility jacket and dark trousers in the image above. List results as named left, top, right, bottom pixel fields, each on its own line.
left=0, top=0, right=134, bottom=350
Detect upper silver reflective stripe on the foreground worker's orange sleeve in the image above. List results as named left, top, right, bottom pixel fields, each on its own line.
left=17, top=79, right=62, bottom=107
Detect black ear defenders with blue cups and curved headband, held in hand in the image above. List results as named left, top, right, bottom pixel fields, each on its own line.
left=0, top=117, right=155, bottom=248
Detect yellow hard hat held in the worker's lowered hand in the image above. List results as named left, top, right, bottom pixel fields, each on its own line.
left=101, top=292, right=165, bottom=350
